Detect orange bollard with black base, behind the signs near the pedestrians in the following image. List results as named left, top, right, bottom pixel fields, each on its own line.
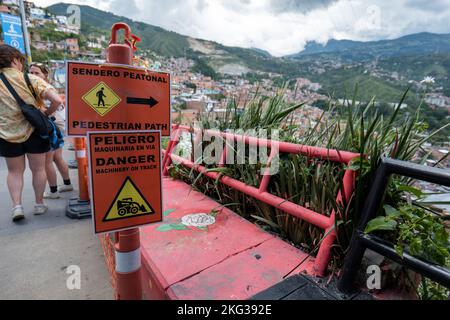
left=66, top=138, right=92, bottom=219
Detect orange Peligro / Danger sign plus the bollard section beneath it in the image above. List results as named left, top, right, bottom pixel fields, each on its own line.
left=88, top=131, right=163, bottom=300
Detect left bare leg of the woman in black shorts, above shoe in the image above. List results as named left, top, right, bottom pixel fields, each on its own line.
left=5, top=156, right=25, bottom=208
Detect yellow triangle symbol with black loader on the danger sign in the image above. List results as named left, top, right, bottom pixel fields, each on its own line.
left=103, top=177, right=155, bottom=222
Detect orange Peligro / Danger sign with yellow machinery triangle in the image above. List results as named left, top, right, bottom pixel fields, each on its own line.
left=88, top=131, right=162, bottom=234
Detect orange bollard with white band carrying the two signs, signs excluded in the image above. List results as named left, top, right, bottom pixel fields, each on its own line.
left=107, top=23, right=142, bottom=300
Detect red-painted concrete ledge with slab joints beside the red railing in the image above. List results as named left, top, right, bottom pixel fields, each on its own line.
left=141, top=178, right=314, bottom=300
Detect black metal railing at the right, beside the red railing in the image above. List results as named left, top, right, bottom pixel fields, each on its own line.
left=338, top=158, right=450, bottom=293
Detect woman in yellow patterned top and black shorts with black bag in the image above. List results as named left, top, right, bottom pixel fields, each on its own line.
left=0, top=44, right=62, bottom=222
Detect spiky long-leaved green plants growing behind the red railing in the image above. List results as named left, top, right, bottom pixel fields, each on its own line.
left=170, top=85, right=450, bottom=298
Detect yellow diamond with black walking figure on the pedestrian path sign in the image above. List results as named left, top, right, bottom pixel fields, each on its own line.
left=83, top=82, right=122, bottom=117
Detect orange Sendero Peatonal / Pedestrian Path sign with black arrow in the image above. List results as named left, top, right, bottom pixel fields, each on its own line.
left=66, top=62, right=171, bottom=136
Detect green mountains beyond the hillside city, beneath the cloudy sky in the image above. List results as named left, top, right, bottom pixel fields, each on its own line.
left=47, top=3, right=450, bottom=102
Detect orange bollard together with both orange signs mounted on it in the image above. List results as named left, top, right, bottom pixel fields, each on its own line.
left=66, top=23, right=171, bottom=300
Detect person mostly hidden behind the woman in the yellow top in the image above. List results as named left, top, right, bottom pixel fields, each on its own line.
left=30, top=63, right=73, bottom=199
